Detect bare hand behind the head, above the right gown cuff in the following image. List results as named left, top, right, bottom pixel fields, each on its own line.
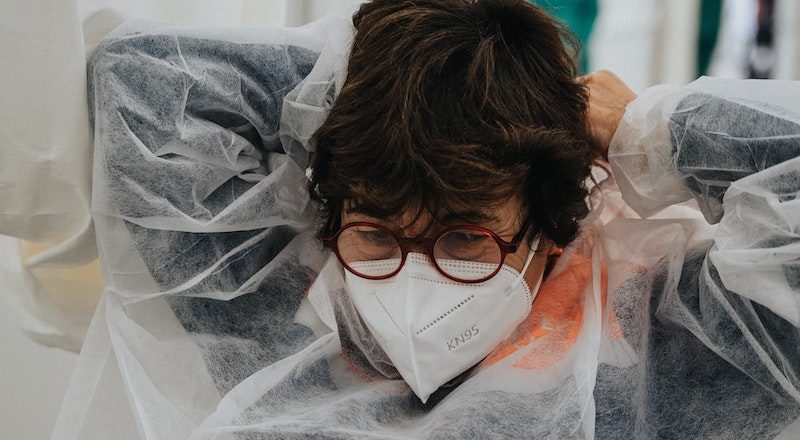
left=579, top=70, right=636, bottom=159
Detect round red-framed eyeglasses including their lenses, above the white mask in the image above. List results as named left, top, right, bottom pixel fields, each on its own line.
left=322, top=222, right=522, bottom=283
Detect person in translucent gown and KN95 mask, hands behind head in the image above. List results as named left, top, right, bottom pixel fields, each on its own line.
left=53, top=0, right=800, bottom=440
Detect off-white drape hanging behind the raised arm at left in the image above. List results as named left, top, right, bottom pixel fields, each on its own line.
left=0, top=0, right=344, bottom=351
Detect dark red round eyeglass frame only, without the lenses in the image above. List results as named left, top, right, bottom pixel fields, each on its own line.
left=322, top=222, right=525, bottom=284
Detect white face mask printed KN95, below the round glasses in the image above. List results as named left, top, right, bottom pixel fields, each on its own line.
left=345, top=239, right=542, bottom=403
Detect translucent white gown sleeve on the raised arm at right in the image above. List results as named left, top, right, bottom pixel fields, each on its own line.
left=609, top=78, right=800, bottom=327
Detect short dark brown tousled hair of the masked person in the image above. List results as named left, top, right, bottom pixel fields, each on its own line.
left=309, top=0, right=594, bottom=246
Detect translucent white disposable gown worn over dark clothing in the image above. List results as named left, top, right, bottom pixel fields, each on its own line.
left=53, top=14, right=800, bottom=440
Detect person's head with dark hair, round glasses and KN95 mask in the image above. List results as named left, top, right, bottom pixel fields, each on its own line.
left=310, top=1, right=604, bottom=402
